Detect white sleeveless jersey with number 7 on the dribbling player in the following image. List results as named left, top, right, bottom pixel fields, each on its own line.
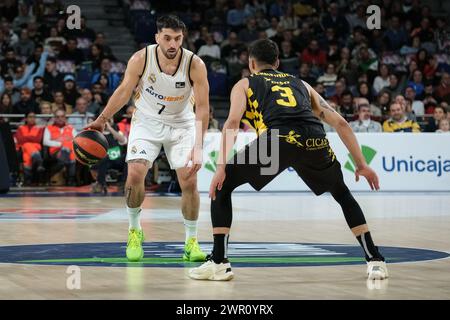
left=134, top=44, right=195, bottom=127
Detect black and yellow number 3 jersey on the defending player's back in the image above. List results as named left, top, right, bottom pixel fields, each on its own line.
left=242, top=69, right=323, bottom=134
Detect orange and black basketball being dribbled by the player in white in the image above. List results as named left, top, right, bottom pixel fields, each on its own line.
left=73, top=130, right=109, bottom=166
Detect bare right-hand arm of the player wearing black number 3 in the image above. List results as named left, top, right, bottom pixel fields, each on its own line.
left=303, top=81, right=380, bottom=190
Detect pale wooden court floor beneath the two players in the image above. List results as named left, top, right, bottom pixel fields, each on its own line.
left=0, top=193, right=450, bottom=300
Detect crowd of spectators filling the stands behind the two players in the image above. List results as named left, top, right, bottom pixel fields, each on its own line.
left=0, top=0, right=450, bottom=192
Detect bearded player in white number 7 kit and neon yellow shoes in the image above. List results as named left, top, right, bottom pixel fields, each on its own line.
left=89, top=16, right=209, bottom=261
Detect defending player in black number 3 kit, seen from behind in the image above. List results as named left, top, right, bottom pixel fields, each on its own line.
left=189, top=40, right=388, bottom=280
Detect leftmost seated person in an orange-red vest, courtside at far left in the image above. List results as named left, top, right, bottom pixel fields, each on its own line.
left=15, top=112, right=45, bottom=185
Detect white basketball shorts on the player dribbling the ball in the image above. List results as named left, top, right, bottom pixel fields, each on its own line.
left=126, top=110, right=195, bottom=170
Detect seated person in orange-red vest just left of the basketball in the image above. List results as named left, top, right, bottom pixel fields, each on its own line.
left=43, top=110, right=77, bottom=186
